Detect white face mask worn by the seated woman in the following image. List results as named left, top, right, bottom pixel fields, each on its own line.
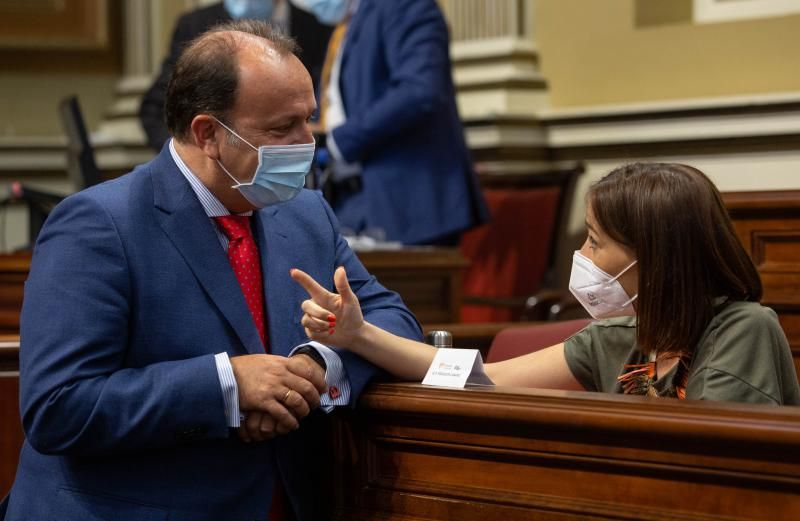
left=569, top=251, right=639, bottom=319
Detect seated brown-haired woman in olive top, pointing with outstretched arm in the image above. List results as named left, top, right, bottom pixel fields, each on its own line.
left=292, top=163, right=800, bottom=405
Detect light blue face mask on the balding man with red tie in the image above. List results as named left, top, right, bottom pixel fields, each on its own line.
left=214, top=118, right=316, bottom=208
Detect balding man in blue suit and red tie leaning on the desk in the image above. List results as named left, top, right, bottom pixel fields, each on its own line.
left=7, top=21, right=421, bottom=521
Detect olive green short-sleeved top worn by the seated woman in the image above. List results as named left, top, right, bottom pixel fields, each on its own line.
left=564, top=300, right=800, bottom=405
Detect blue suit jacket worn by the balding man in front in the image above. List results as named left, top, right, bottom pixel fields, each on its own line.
left=8, top=147, right=421, bottom=520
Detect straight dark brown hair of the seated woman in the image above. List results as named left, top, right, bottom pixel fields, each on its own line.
left=588, top=163, right=762, bottom=355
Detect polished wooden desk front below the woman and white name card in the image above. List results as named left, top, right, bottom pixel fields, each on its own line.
left=332, top=384, right=800, bottom=521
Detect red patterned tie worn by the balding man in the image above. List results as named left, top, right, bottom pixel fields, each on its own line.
left=214, top=215, right=268, bottom=351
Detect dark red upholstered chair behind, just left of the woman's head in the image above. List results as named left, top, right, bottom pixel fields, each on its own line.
left=461, top=162, right=583, bottom=322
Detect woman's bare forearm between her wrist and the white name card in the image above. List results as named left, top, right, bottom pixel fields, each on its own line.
left=349, top=322, right=436, bottom=382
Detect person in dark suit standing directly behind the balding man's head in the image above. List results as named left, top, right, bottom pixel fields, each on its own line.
left=139, top=0, right=333, bottom=150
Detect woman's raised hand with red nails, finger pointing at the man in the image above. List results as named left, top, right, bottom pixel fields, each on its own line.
left=289, top=266, right=364, bottom=349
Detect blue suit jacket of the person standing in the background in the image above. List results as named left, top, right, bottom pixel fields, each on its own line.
left=333, top=0, right=487, bottom=244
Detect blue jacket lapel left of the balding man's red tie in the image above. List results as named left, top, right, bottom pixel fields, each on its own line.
left=153, top=147, right=264, bottom=353
